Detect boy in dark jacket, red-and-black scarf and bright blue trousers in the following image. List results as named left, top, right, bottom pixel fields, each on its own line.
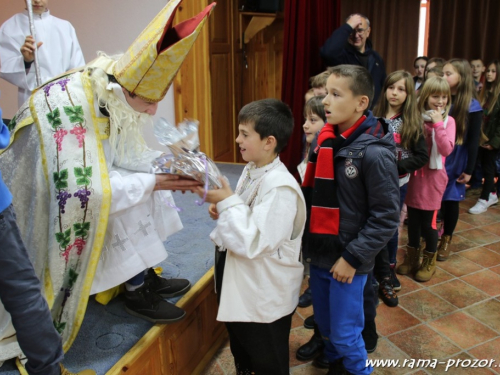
left=302, top=65, right=399, bottom=375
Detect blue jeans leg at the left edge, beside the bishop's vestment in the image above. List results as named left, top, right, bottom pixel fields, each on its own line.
left=0, top=205, right=64, bottom=375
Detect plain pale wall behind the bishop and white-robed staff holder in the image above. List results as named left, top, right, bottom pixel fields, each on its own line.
left=0, top=0, right=175, bottom=147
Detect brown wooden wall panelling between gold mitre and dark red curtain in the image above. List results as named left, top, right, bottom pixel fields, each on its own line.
left=174, top=0, right=283, bottom=162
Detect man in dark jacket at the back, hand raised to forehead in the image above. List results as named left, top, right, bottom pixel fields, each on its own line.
left=320, top=13, right=386, bottom=109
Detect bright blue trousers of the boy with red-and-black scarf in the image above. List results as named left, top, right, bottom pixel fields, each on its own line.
left=310, top=265, right=373, bottom=375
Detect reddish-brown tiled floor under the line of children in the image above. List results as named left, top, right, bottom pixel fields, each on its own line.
left=203, top=191, right=500, bottom=375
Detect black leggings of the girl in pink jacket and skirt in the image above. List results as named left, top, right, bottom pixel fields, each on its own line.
left=408, top=207, right=438, bottom=253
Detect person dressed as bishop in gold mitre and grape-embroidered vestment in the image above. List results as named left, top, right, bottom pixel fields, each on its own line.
left=0, top=0, right=215, bottom=368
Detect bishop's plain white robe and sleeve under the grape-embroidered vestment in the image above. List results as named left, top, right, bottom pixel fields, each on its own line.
left=90, top=140, right=182, bottom=294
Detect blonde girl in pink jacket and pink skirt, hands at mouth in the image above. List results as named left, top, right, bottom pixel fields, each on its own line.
left=405, top=77, right=455, bottom=281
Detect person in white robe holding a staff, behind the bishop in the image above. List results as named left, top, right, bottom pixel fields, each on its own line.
left=0, top=0, right=85, bottom=107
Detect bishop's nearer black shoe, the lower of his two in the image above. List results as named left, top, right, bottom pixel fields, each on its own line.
left=125, top=285, right=186, bottom=324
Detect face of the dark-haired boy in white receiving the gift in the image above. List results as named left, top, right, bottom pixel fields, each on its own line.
left=236, top=122, right=268, bottom=167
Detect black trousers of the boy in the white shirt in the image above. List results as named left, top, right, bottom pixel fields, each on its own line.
left=215, top=251, right=293, bottom=375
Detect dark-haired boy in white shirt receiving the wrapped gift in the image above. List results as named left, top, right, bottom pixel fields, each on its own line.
left=198, top=99, right=306, bottom=375
